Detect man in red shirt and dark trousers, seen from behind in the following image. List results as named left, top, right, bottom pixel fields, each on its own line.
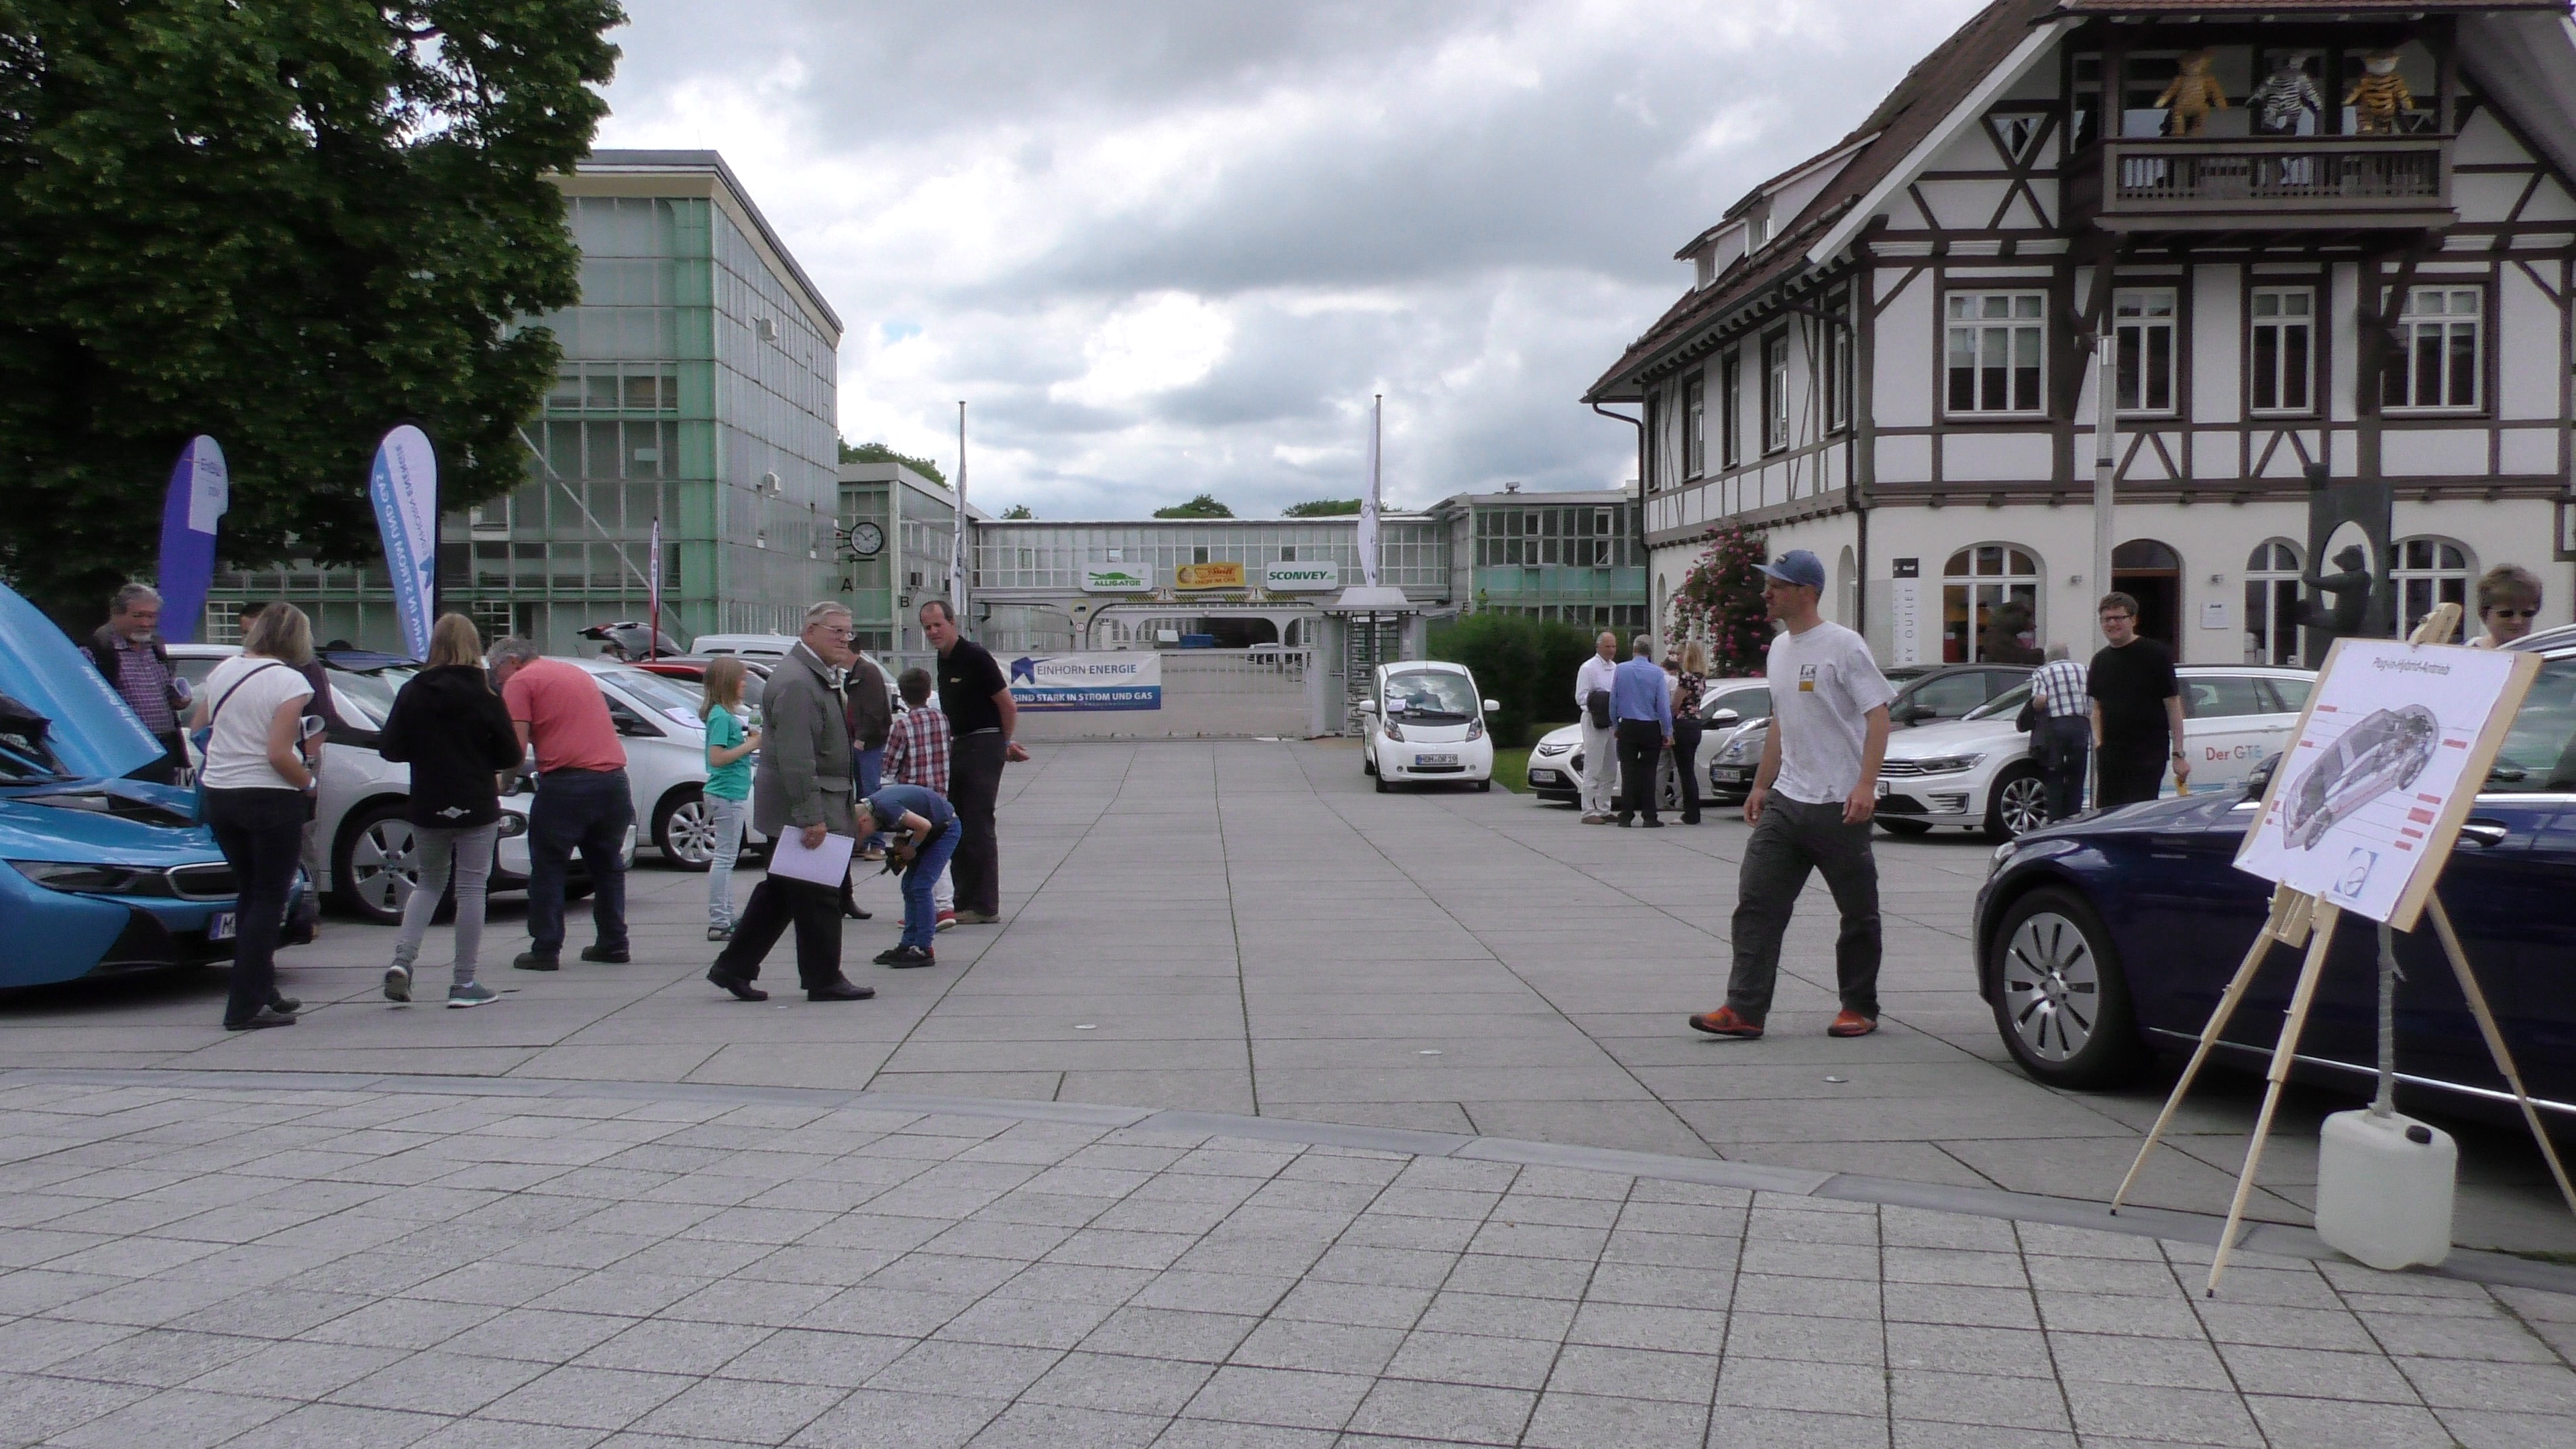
left=490, top=639, right=636, bottom=972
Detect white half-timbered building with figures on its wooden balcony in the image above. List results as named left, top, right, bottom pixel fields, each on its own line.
left=1587, top=0, right=2576, bottom=663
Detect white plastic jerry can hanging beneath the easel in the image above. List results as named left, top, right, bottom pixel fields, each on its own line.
left=2316, top=1112, right=2460, bottom=1269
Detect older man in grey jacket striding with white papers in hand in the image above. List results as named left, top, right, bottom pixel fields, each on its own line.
left=706, top=601, right=876, bottom=1000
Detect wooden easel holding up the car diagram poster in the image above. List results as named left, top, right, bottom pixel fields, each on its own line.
left=2110, top=603, right=2576, bottom=1297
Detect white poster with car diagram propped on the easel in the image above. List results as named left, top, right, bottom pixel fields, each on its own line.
left=2236, top=639, right=2540, bottom=930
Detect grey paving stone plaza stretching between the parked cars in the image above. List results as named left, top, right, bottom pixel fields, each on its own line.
left=0, top=743, right=2576, bottom=1449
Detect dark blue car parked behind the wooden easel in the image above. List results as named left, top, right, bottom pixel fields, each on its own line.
left=1976, top=629, right=2576, bottom=1129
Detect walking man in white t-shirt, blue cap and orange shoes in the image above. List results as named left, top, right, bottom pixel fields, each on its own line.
left=1690, top=549, right=1896, bottom=1039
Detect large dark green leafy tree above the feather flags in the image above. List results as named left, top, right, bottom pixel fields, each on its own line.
left=0, top=0, right=623, bottom=621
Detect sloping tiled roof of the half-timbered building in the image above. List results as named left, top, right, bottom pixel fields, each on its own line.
left=1585, top=0, right=2061, bottom=402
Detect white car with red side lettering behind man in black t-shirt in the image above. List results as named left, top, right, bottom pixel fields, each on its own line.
left=1878, top=665, right=2316, bottom=841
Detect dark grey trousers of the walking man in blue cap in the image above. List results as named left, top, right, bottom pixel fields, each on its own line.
left=1726, top=794, right=1878, bottom=1021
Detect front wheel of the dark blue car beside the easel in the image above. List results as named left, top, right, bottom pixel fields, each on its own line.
left=1986, top=890, right=2146, bottom=1088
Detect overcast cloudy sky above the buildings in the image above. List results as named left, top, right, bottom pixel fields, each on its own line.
left=600, top=0, right=1978, bottom=519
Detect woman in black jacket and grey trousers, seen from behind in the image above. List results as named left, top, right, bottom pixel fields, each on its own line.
left=376, top=614, right=521, bottom=1008
